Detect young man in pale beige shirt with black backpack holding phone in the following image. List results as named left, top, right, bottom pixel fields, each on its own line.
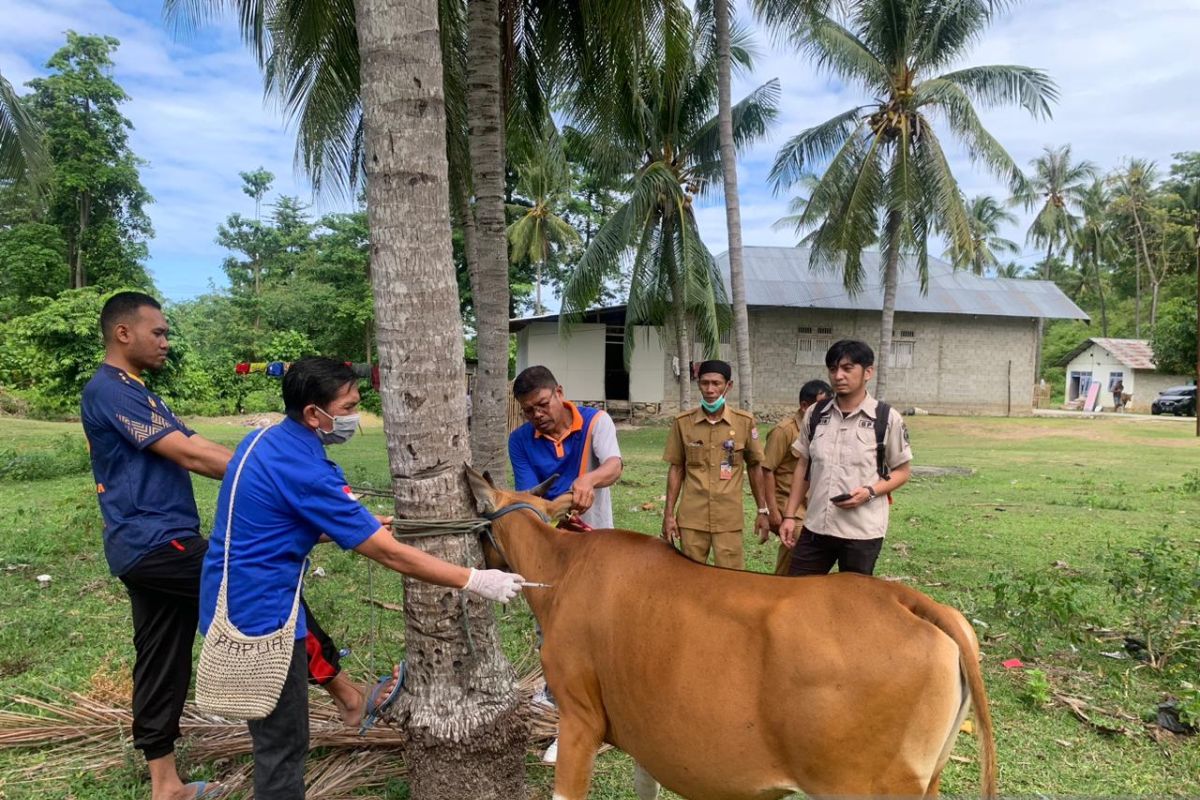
left=779, top=339, right=912, bottom=575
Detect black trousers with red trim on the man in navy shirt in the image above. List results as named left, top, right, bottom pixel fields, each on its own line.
left=120, top=536, right=341, bottom=760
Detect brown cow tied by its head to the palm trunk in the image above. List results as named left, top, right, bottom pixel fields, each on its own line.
left=468, top=470, right=996, bottom=800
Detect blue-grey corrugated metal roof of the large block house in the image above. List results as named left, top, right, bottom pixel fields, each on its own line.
left=716, top=247, right=1090, bottom=319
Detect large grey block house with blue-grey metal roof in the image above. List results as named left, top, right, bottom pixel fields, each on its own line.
left=510, top=247, right=1088, bottom=416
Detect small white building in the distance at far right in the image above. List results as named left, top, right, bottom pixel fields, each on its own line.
left=1058, top=337, right=1193, bottom=414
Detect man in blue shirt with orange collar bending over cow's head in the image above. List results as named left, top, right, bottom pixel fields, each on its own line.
left=509, top=366, right=624, bottom=529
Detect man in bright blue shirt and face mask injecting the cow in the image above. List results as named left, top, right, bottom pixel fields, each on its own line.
left=200, top=359, right=524, bottom=800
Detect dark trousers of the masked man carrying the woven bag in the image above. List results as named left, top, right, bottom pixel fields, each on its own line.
left=246, top=639, right=308, bottom=800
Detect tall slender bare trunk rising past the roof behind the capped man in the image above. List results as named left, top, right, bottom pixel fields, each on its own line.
left=713, top=0, right=754, bottom=411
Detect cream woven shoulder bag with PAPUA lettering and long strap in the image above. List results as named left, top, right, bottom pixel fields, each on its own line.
left=196, top=428, right=307, bottom=720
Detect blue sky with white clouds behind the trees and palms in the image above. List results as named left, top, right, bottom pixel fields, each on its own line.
left=0, top=0, right=1200, bottom=301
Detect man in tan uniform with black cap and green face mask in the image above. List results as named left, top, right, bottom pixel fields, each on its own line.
left=662, top=360, right=768, bottom=570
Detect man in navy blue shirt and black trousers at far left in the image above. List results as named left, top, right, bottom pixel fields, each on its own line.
left=82, top=291, right=232, bottom=800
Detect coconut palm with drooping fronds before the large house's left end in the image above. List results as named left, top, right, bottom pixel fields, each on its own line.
left=562, top=10, right=779, bottom=408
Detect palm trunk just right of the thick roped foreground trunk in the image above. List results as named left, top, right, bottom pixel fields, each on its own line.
left=467, top=0, right=509, bottom=474
